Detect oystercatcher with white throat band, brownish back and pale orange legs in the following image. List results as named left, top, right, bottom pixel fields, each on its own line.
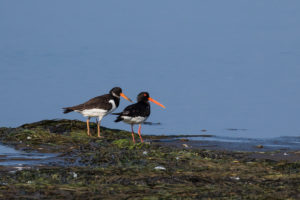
left=63, top=87, right=132, bottom=137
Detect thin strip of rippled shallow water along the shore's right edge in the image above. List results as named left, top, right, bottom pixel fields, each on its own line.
left=156, top=135, right=300, bottom=152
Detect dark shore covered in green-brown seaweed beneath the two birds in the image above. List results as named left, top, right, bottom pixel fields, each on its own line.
left=0, top=120, right=300, bottom=199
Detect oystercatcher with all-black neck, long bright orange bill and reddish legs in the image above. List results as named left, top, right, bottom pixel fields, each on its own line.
left=113, top=92, right=165, bottom=143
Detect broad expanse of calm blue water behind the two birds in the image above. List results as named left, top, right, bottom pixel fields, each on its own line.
left=0, top=0, right=300, bottom=138
